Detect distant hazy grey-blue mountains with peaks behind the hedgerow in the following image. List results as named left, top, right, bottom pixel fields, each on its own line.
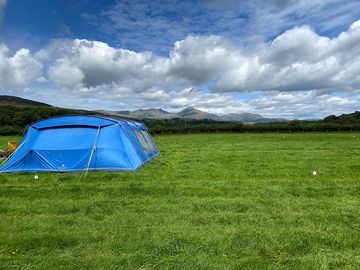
left=99, top=107, right=288, bottom=123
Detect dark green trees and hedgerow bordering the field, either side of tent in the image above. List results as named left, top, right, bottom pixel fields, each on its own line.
left=0, top=106, right=360, bottom=135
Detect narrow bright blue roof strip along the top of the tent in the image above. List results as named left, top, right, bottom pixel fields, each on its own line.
left=31, top=115, right=137, bottom=129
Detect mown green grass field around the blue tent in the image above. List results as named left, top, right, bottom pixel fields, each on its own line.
left=0, top=133, right=360, bottom=269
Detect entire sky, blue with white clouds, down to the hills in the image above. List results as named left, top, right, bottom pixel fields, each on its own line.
left=0, top=0, right=360, bottom=119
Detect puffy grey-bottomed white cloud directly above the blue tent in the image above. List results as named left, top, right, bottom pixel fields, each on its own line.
left=41, top=39, right=156, bottom=91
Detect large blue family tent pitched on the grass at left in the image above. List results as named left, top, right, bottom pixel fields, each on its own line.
left=0, top=116, right=159, bottom=172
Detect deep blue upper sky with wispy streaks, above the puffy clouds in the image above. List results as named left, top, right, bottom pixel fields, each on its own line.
left=1, top=0, right=360, bottom=54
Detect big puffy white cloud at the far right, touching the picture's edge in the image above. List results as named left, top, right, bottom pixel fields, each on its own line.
left=217, top=23, right=360, bottom=91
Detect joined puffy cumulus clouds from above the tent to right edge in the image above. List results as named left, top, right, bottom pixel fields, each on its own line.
left=37, top=19, right=360, bottom=96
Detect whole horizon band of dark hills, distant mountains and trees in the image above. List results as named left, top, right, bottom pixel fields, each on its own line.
left=0, top=95, right=360, bottom=129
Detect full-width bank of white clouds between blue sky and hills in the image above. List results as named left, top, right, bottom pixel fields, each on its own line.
left=0, top=21, right=360, bottom=116
